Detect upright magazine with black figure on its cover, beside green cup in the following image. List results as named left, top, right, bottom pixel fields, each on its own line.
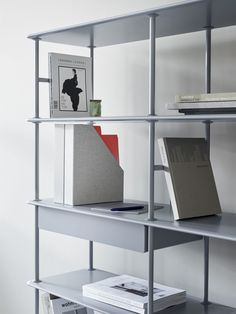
left=49, top=53, right=92, bottom=118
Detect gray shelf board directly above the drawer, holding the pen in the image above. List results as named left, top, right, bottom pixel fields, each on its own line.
left=30, top=200, right=236, bottom=241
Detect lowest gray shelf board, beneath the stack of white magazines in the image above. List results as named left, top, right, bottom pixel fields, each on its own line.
left=28, top=270, right=236, bottom=314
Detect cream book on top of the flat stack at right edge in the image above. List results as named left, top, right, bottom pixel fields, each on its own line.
left=175, top=93, right=236, bottom=102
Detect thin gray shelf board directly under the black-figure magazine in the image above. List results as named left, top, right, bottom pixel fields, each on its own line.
left=28, top=114, right=236, bottom=124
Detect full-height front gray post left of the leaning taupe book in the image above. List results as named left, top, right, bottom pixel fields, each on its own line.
left=148, top=14, right=156, bottom=314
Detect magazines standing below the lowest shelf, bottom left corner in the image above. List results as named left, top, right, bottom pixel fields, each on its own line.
left=41, top=293, right=90, bottom=314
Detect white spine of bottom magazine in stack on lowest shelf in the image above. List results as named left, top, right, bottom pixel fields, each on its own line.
left=83, top=291, right=146, bottom=314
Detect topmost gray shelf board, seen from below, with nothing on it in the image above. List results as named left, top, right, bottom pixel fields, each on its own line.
left=29, top=0, right=236, bottom=47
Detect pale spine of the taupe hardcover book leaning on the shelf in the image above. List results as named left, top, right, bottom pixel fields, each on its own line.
left=158, top=138, right=179, bottom=220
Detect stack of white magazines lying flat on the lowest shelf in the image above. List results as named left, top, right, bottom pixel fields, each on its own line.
left=83, top=275, right=186, bottom=314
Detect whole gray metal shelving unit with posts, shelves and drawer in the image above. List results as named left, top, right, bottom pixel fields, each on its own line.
left=29, top=0, right=236, bottom=314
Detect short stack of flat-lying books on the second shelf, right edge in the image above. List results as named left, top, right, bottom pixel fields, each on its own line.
left=167, top=93, right=236, bottom=114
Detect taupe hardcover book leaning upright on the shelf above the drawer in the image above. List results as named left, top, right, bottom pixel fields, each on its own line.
left=158, top=138, right=221, bottom=220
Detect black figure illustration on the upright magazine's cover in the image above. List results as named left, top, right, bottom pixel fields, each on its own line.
left=62, top=69, right=83, bottom=111
